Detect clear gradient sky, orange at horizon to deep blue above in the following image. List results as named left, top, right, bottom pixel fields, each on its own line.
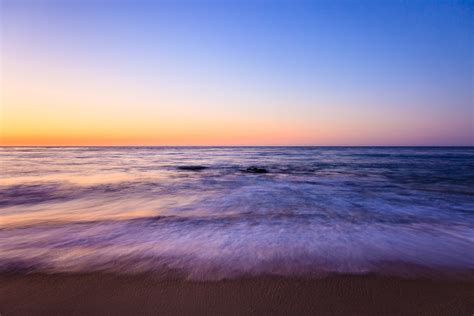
left=0, top=0, right=474, bottom=146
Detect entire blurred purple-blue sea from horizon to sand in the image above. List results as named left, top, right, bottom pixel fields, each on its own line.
left=0, top=147, right=474, bottom=279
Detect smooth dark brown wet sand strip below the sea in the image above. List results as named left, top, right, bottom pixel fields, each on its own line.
left=0, top=273, right=474, bottom=316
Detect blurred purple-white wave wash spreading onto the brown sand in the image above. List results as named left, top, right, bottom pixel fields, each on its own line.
left=0, top=218, right=474, bottom=279
